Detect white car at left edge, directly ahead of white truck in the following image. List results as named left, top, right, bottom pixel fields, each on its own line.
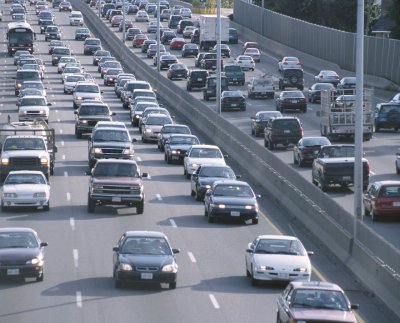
left=1, top=170, right=50, bottom=211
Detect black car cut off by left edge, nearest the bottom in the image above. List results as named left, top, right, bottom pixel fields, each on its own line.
left=0, top=228, right=47, bottom=281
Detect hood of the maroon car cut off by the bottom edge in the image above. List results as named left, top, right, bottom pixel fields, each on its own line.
left=291, top=308, right=357, bottom=323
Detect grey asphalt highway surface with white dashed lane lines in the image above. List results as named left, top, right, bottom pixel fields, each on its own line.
left=0, top=1, right=397, bottom=323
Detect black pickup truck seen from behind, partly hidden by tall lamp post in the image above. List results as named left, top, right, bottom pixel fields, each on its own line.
left=311, top=145, right=369, bottom=192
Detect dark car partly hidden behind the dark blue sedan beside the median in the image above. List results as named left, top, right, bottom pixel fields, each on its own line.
left=190, top=164, right=241, bottom=201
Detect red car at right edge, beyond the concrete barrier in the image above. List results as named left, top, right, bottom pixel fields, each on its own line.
left=363, top=180, right=400, bottom=221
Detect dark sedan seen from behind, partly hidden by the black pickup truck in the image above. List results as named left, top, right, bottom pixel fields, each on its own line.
left=293, top=137, right=331, bottom=167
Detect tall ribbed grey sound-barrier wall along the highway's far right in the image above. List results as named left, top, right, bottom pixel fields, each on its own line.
left=233, top=0, right=400, bottom=84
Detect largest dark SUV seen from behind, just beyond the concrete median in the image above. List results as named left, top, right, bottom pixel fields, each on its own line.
left=264, top=117, right=303, bottom=150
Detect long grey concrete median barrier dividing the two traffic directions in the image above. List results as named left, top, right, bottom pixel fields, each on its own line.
left=71, top=0, right=400, bottom=316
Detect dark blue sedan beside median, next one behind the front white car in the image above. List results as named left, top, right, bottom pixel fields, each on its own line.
left=204, top=179, right=260, bottom=224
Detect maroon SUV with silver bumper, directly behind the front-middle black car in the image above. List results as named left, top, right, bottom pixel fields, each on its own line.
left=87, top=159, right=147, bottom=214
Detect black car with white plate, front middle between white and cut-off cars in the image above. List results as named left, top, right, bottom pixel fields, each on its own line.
left=113, top=231, right=179, bottom=289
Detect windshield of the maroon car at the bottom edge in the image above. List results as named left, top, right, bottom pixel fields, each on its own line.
left=291, top=289, right=349, bottom=311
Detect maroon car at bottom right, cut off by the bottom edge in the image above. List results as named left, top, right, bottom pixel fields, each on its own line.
left=276, top=281, right=359, bottom=323
